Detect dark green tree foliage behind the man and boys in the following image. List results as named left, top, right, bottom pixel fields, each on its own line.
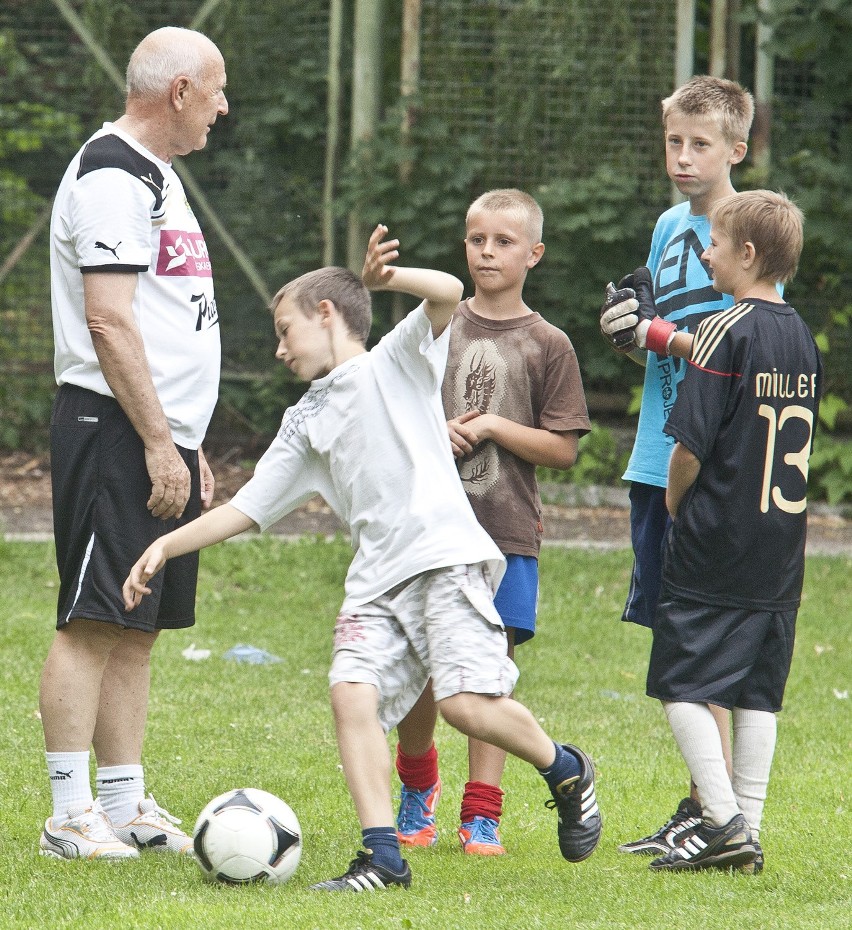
left=0, top=0, right=852, bottom=474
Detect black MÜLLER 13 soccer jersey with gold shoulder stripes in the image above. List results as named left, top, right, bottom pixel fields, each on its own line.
left=663, top=300, right=822, bottom=610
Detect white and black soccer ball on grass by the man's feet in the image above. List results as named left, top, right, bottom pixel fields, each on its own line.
left=192, top=788, right=302, bottom=885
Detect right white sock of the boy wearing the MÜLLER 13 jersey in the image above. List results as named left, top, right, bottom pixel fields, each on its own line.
left=732, top=707, right=777, bottom=839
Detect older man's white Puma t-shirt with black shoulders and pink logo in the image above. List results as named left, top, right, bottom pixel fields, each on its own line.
left=50, top=123, right=221, bottom=449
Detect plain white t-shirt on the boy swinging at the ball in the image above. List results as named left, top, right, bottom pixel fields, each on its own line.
left=231, top=305, right=504, bottom=606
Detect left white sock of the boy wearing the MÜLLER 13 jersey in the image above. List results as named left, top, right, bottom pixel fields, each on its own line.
left=663, top=702, right=740, bottom=827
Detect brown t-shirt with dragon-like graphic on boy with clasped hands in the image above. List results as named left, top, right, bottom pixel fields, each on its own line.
left=442, top=300, right=590, bottom=557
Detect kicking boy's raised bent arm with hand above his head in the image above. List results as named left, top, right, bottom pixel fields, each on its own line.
left=361, top=223, right=464, bottom=338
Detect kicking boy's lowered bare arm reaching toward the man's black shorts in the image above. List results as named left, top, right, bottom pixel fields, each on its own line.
left=121, top=504, right=257, bottom=610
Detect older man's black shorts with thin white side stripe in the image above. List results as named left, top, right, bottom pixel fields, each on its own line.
left=50, top=384, right=201, bottom=632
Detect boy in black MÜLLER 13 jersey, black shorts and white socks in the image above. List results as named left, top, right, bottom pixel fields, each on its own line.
left=647, top=191, right=822, bottom=872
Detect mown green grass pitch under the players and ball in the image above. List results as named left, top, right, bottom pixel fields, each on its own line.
left=0, top=539, right=852, bottom=930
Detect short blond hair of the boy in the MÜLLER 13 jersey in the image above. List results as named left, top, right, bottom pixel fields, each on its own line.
left=709, top=191, right=805, bottom=284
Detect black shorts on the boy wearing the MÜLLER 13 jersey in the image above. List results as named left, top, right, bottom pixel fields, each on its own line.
left=647, top=586, right=798, bottom=713
